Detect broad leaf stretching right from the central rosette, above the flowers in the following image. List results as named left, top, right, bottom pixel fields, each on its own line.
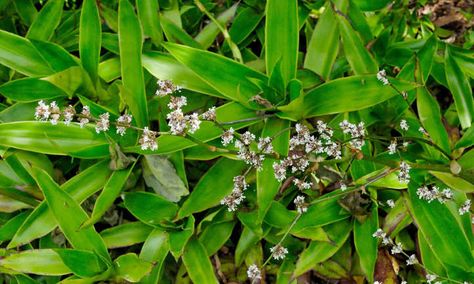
left=278, top=75, right=416, bottom=120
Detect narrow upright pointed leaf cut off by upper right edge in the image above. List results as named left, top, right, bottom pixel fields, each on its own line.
left=444, top=46, right=474, bottom=129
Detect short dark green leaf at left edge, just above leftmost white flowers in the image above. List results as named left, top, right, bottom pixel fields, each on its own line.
left=0, top=78, right=66, bottom=102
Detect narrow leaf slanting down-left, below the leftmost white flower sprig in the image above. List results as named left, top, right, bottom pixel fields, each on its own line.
left=82, top=163, right=135, bottom=228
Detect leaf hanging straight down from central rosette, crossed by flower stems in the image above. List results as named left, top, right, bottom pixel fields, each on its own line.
left=257, top=118, right=290, bottom=221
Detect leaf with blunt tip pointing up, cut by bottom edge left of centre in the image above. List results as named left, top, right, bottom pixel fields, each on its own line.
left=183, top=239, right=219, bottom=284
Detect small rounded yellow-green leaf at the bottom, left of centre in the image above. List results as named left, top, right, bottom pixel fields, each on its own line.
left=114, top=253, right=152, bottom=283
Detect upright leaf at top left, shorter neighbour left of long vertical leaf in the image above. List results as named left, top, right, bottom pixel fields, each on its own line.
left=79, top=0, right=102, bottom=84
